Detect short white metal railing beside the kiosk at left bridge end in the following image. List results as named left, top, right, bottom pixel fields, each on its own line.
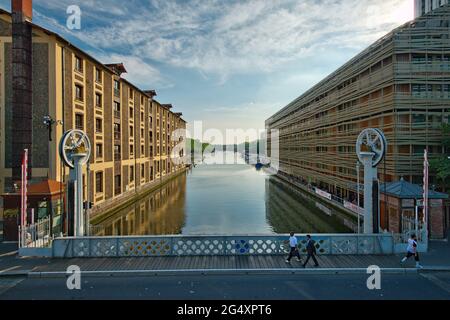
left=19, top=217, right=53, bottom=248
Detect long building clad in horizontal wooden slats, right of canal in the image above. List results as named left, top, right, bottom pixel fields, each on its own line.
left=266, top=5, right=450, bottom=232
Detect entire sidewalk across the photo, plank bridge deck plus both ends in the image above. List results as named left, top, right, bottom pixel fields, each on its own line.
left=0, top=238, right=450, bottom=277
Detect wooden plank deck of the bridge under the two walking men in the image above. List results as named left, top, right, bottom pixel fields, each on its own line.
left=33, top=255, right=414, bottom=272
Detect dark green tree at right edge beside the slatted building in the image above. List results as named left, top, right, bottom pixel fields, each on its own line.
left=430, top=124, right=450, bottom=192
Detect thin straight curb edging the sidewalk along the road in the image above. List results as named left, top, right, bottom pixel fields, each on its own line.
left=27, top=268, right=418, bottom=278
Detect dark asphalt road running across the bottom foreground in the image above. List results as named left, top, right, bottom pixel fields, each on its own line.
left=0, top=273, right=450, bottom=300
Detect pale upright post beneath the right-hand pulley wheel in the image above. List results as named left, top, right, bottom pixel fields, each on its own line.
left=361, top=152, right=377, bottom=234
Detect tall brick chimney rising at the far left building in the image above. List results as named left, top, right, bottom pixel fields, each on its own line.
left=11, top=0, right=33, bottom=182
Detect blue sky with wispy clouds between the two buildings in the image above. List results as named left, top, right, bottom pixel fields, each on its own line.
left=0, top=0, right=414, bottom=142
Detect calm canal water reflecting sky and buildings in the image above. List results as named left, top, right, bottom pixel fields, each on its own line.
left=94, top=154, right=356, bottom=236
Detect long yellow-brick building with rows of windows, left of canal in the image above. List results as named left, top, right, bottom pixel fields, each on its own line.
left=0, top=0, right=186, bottom=238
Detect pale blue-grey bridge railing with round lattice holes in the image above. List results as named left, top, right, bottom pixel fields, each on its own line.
left=52, top=234, right=406, bottom=258
